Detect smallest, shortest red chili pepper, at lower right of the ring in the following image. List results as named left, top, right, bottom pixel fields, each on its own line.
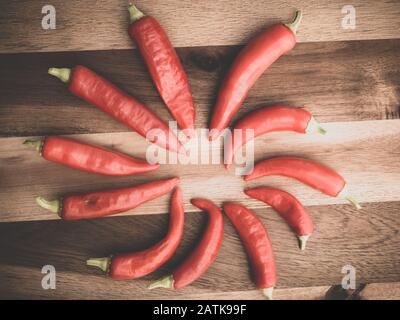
left=244, top=187, right=314, bottom=250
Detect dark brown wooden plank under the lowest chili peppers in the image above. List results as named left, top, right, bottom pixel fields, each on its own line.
left=0, top=202, right=400, bottom=299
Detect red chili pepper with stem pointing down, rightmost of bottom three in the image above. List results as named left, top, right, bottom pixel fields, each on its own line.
left=223, top=202, right=276, bottom=300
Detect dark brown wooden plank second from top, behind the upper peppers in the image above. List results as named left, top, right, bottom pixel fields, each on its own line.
left=0, top=40, right=400, bottom=136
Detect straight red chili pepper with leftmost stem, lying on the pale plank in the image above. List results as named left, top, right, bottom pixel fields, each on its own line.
left=24, top=137, right=160, bottom=176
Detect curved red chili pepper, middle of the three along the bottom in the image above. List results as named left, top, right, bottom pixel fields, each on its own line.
left=148, top=199, right=224, bottom=289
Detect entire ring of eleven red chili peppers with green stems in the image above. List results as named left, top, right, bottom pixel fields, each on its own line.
left=24, top=4, right=359, bottom=299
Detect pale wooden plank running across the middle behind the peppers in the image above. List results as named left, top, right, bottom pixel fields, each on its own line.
left=0, top=120, right=400, bottom=221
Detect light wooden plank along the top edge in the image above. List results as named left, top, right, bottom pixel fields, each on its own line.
left=0, top=0, right=400, bottom=53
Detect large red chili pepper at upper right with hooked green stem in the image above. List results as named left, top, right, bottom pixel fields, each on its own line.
left=209, top=11, right=302, bottom=140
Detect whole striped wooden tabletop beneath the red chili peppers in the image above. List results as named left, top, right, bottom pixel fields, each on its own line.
left=0, top=0, right=400, bottom=299
